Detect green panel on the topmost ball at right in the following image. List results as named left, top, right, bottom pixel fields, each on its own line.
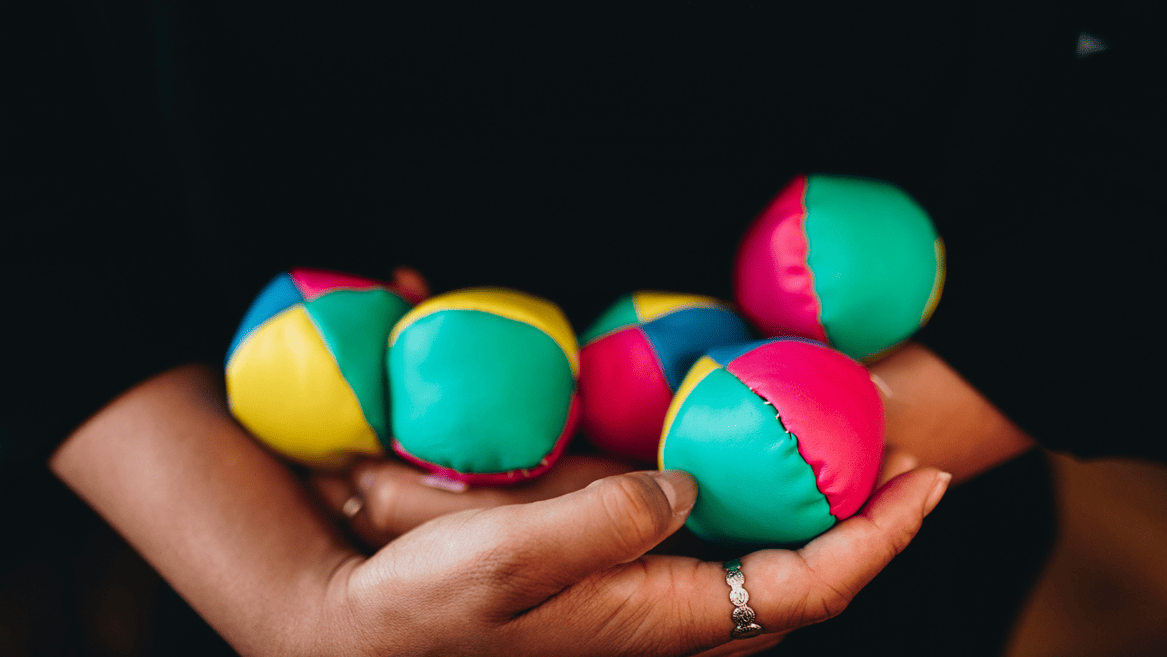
left=805, top=175, right=938, bottom=359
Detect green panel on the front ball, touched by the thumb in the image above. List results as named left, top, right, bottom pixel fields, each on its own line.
left=662, top=369, right=836, bottom=544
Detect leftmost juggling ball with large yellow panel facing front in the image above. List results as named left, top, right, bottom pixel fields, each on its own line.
left=226, top=268, right=411, bottom=467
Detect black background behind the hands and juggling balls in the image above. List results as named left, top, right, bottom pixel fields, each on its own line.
left=0, top=1, right=1167, bottom=655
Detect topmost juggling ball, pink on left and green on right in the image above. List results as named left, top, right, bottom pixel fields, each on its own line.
left=734, top=174, right=944, bottom=359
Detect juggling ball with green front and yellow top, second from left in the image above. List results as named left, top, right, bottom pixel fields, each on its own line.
left=387, top=288, right=579, bottom=484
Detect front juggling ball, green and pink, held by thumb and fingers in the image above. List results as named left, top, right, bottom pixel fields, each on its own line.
left=659, top=337, right=883, bottom=544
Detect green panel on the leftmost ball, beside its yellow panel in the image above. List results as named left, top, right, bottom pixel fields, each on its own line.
left=305, top=289, right=410, bottom=439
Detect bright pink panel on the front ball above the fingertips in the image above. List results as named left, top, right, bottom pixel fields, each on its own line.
left=726, top=340, right=883, bottom=519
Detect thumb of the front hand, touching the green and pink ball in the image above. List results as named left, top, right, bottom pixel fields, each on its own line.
left=496, top=470, right=697, bottom=609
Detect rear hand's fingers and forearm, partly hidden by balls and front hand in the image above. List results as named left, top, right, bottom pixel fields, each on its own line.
left=313, top=343, right=1034, bottom=547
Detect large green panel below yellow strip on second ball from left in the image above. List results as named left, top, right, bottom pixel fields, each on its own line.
left=387, top=309, right=575, bottom=473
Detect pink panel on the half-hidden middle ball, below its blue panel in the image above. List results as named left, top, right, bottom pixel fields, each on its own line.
left=579, top=327, right=672, bottom=462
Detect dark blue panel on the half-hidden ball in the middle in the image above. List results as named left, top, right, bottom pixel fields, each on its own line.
left=641, top=308, right=750, bottom=391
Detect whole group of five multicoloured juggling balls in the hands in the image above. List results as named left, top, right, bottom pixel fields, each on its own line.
left=226, top=175, right=944, bottom=544
